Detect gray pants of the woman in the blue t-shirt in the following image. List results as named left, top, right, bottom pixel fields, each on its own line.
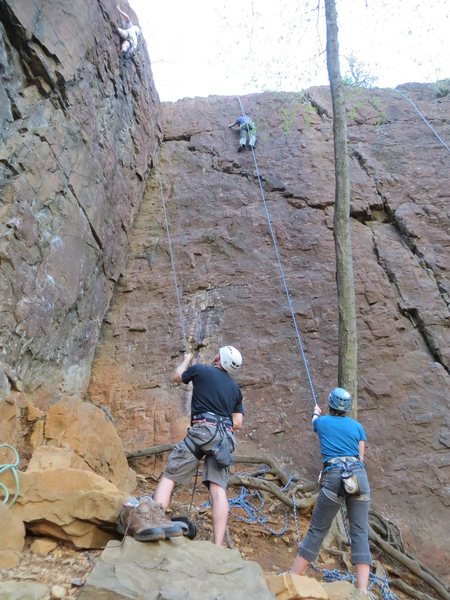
left=298, top=468, right=372, bottom=565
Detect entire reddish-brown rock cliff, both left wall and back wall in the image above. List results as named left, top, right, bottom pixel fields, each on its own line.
left=0, top=0, right=450, bottom=576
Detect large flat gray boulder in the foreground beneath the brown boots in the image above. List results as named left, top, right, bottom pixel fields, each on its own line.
left=78, top=537, right=274, bottom=600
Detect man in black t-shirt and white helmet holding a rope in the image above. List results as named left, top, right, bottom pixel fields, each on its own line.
left=153, top=346, right=244, bottom=545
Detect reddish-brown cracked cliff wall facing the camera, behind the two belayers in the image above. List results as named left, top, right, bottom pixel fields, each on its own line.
left=90, top=85, right=450, bottom=571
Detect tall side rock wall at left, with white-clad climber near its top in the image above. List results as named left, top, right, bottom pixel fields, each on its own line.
left=0, top=0, right=161, bottom=407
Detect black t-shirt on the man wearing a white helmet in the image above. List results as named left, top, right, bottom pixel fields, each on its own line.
left=181, top=365, right=244, bottom=419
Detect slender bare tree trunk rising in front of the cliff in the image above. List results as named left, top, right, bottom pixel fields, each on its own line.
left=325, top=0, right=357, bottom=417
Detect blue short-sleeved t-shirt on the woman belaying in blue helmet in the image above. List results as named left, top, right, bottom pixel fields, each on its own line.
left=313, top=415, right=366, bottom=462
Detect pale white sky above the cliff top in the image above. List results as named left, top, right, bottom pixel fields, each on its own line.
left=128, top=0, right=450, bottom=101
